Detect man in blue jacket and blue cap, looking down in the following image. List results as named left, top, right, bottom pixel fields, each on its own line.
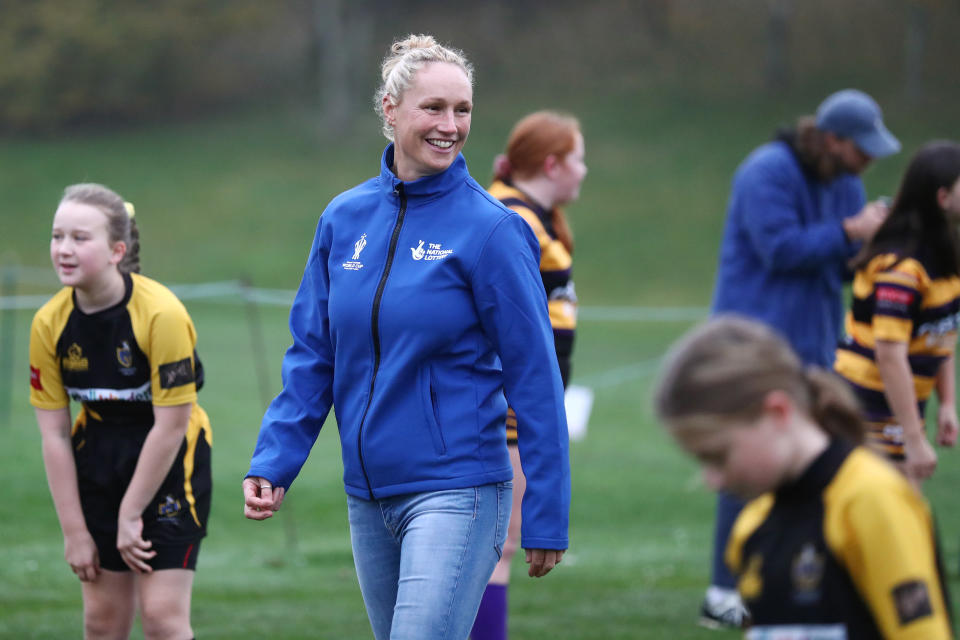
left=701, top=89, right=900, bottom=627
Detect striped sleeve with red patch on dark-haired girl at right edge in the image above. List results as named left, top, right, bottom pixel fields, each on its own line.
left=871, top=260, right=929, bottom=342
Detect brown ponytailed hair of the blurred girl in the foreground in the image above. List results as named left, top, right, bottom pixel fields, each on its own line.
left=654, top=315, right=865, bottom=444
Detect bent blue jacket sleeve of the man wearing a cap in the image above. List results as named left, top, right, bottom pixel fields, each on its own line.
left=734, top=163, right=863, bottom=272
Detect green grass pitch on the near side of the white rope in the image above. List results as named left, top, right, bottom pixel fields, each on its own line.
left=0, top=300, right=960, bottom=640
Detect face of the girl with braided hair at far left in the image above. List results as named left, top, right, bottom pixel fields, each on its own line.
left=50, top=200, right=126, bottom=290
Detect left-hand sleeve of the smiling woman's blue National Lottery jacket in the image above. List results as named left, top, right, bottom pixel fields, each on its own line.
left=247, top=216, right=333, bottom=489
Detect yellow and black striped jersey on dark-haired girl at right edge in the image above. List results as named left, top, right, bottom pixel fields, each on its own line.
left=834, top=253, right=960, bottom=456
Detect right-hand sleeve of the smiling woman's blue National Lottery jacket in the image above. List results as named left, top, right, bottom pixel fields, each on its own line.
left=471, top=213, right=570, bottom=549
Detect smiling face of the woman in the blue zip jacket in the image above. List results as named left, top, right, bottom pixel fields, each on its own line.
left=383, top=62, right=473, bottom=181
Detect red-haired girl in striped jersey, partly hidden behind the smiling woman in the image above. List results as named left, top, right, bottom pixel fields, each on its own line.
left=470, top=111, right=587, bottom=640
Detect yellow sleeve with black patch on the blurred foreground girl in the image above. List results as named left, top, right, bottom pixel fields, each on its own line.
left=834, top=485, right=952, bottom=640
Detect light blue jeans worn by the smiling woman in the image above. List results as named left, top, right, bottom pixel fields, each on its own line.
left=347, top=482, right=513, bottom=640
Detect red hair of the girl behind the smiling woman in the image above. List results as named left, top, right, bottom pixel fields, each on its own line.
left=494, top=111, right=580, bottom=254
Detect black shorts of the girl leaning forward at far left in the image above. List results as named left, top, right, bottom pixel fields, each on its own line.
left=73, top=420, right=212, bottom=571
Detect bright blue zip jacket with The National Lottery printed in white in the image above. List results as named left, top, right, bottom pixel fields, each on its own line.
left=248, top=145, right=570, bottom=549
